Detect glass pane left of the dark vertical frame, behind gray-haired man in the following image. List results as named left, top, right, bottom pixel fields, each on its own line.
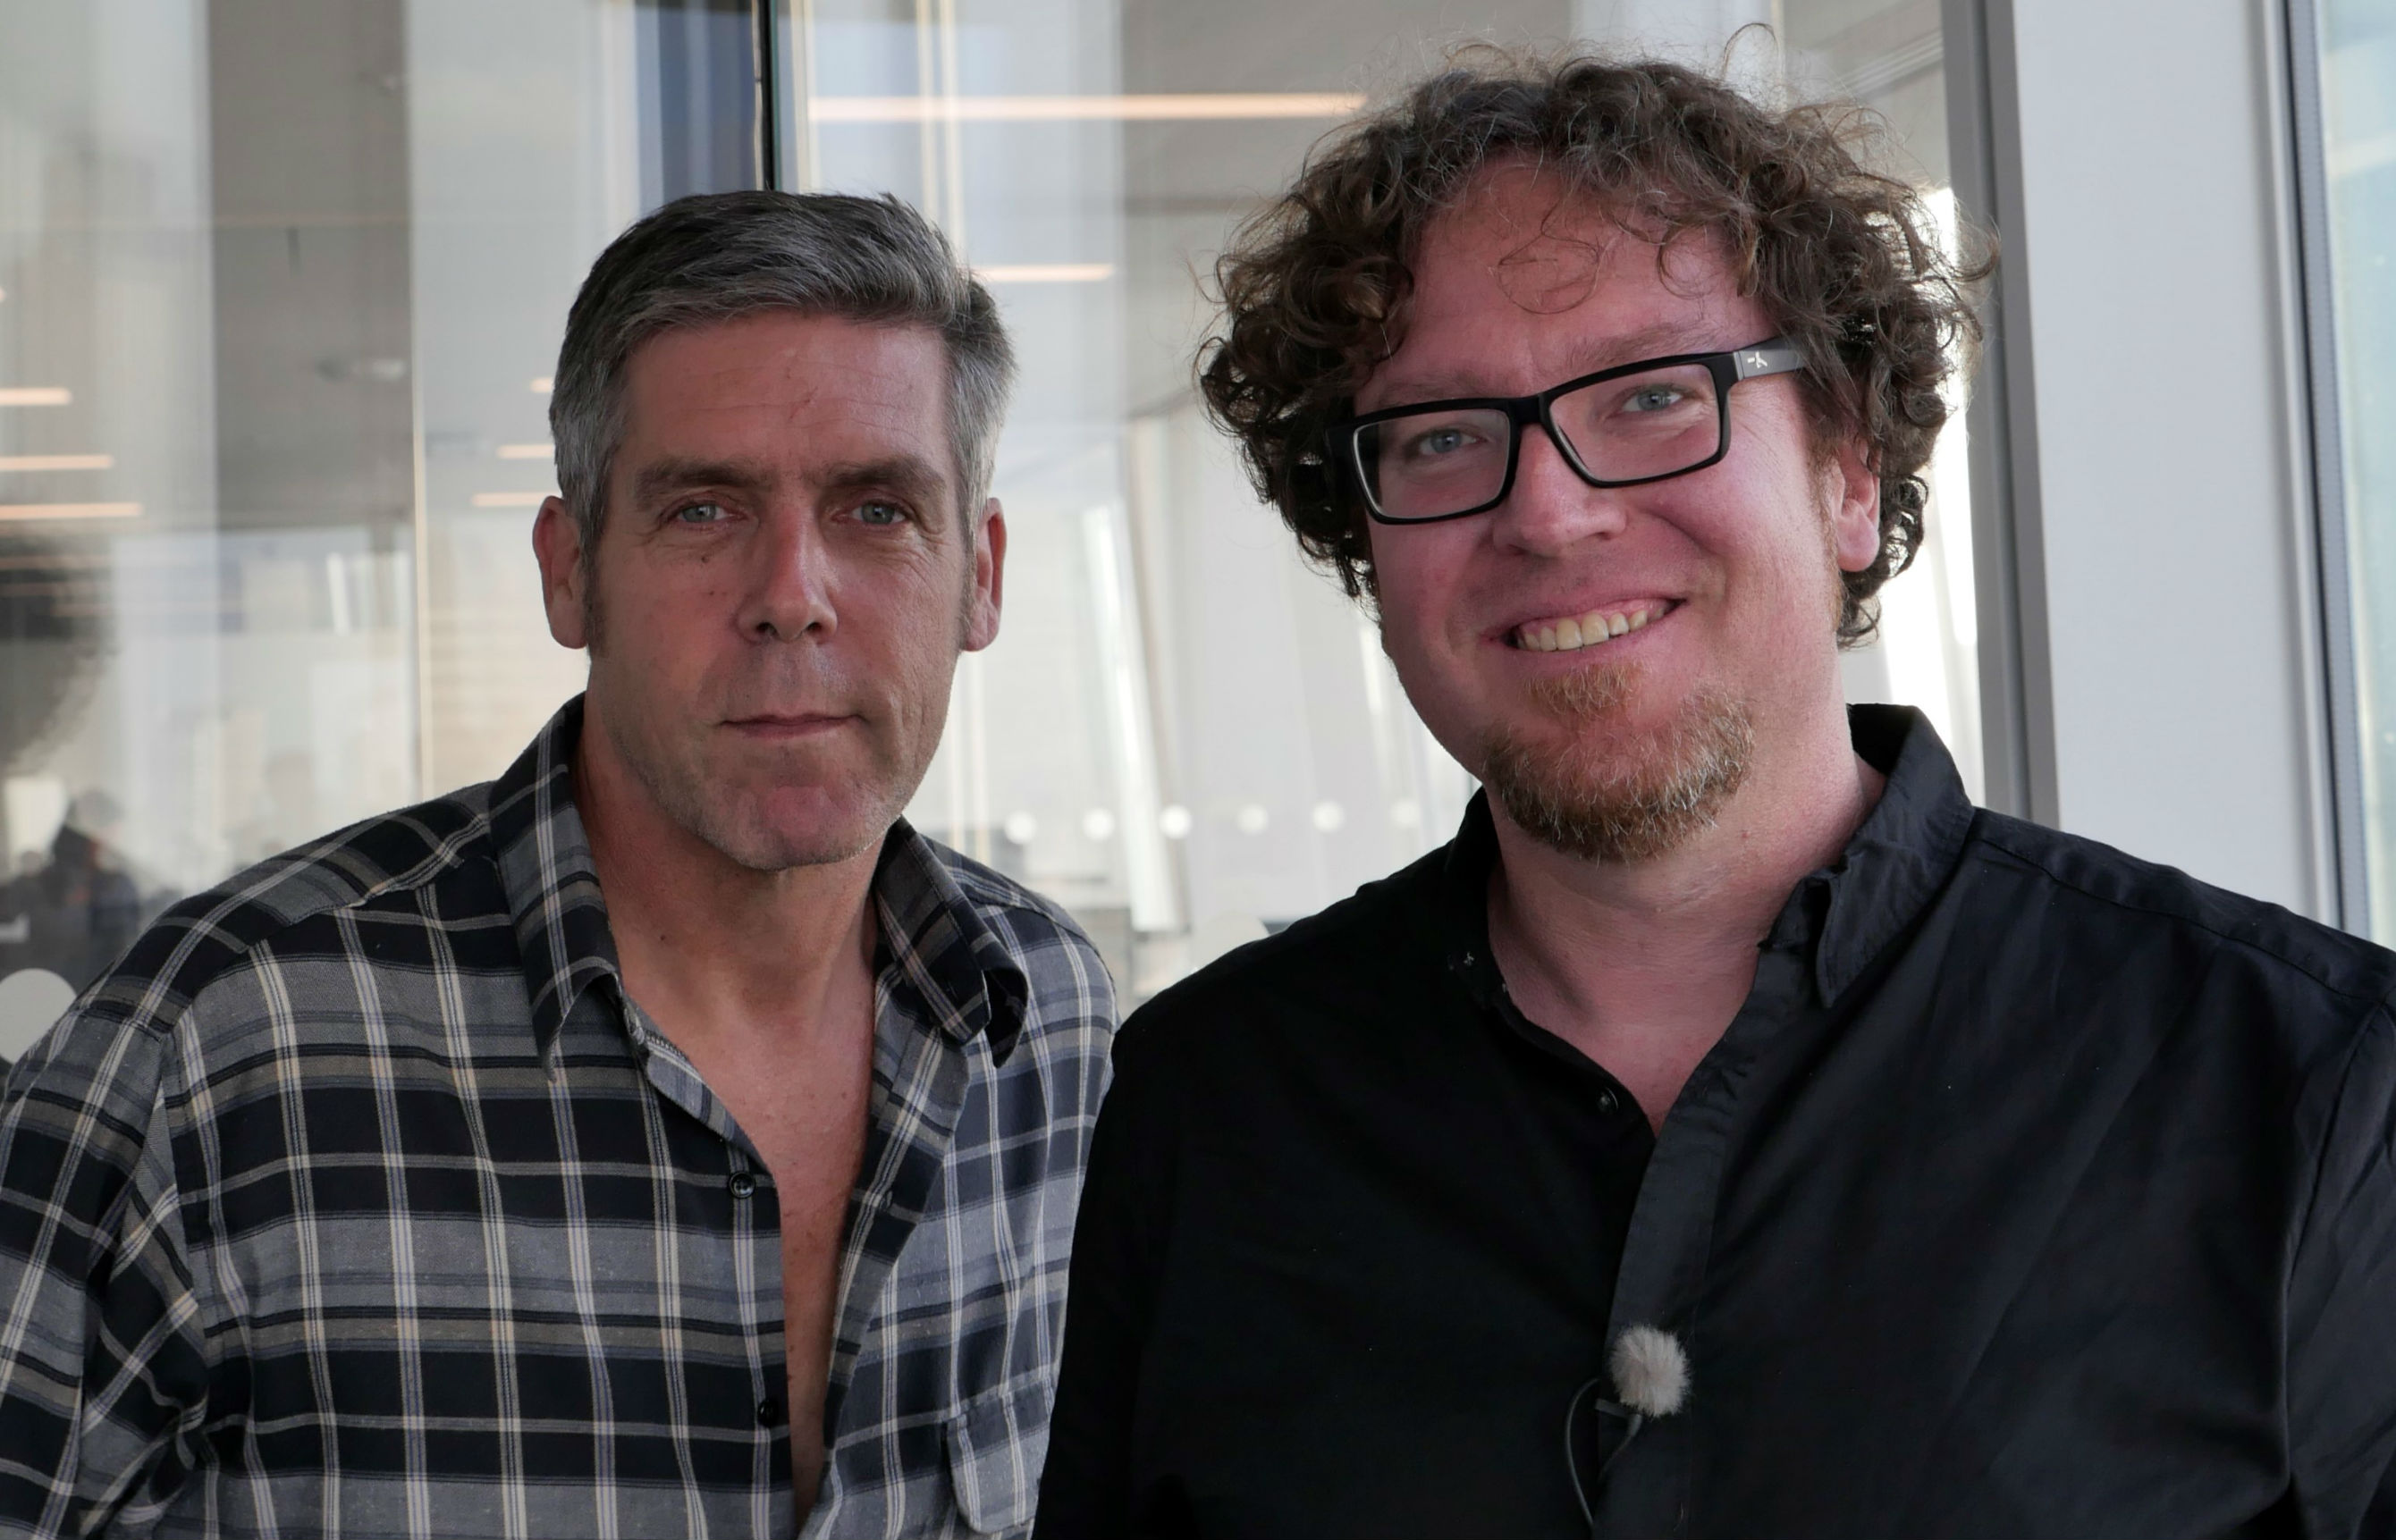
left=0, top=0, right=757, bottom=1058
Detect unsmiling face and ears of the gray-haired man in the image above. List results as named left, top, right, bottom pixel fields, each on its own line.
left=536, top=311, right=1007, bottom=871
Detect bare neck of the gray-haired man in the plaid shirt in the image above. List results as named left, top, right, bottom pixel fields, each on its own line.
left=575, top=702, right=882, bottom=1051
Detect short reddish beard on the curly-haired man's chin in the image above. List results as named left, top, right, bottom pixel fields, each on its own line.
left=1481, top=663, right=1754, bottom=863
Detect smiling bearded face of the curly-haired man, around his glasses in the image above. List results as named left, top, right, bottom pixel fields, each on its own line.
left=1356, top=165, right=1878, bottom=860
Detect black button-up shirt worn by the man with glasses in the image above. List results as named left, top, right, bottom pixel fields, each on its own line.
left=1037, top=706, right=2396, bottom=1540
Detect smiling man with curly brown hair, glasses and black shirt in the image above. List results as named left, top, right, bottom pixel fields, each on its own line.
left=1037, top=57, right=2396, bottom=1540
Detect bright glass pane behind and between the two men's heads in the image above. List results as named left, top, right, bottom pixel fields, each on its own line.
left=781, top=0, right=1979, bottom=998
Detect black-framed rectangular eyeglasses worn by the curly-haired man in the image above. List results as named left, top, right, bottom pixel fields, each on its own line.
left=1329, top=338, right=1804, bottom=525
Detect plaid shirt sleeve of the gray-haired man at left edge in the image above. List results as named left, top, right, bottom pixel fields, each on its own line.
left=0, top=1008, right=206, bottom=1537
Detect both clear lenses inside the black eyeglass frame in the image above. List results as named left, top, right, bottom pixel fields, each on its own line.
left=1356, top=364, right=1723, bottom=519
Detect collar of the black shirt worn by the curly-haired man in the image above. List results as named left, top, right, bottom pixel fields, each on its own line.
left=1440, top=706, right=1974, bottom=1004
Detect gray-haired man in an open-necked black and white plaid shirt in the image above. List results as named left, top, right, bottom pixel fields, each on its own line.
left=0, top=191, right=1112, bottom=1540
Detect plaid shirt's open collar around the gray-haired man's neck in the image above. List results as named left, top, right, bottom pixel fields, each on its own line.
left=491, top=694, right=1030, bottom=1061
